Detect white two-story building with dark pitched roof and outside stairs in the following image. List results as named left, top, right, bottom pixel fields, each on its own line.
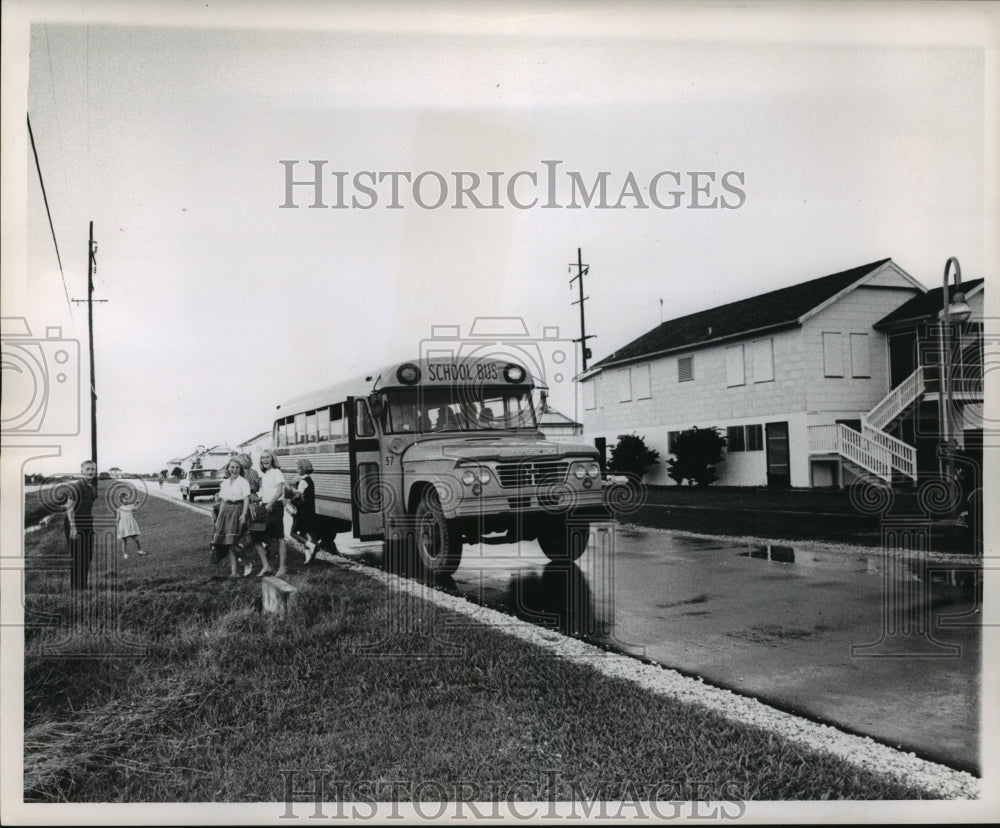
left=579, top=259, right=982, bottom=486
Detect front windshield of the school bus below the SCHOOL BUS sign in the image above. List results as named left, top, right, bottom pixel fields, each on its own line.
left=382, top=386, right=537, bottom=434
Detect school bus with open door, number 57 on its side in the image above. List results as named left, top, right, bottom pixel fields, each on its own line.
left=272, top=356, right=606, bottom=574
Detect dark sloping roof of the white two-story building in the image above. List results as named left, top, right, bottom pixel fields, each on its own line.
left=591, top=259, right=891, bottom=370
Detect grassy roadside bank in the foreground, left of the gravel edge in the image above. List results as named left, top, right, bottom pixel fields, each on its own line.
left=24, top=488, right=936, bottom=802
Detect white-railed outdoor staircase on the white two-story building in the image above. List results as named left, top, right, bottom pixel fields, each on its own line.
left=809, top=366, right=926, bottom=483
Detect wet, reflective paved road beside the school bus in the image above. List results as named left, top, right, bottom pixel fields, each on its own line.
left=348, top=526, right=981, bottom=772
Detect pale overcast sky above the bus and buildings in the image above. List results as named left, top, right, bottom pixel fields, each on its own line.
left=3, top=2, right=1000, bottom=473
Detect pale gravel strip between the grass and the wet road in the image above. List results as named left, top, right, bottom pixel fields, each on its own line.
left=326, top=548, right=980, bottom=799
